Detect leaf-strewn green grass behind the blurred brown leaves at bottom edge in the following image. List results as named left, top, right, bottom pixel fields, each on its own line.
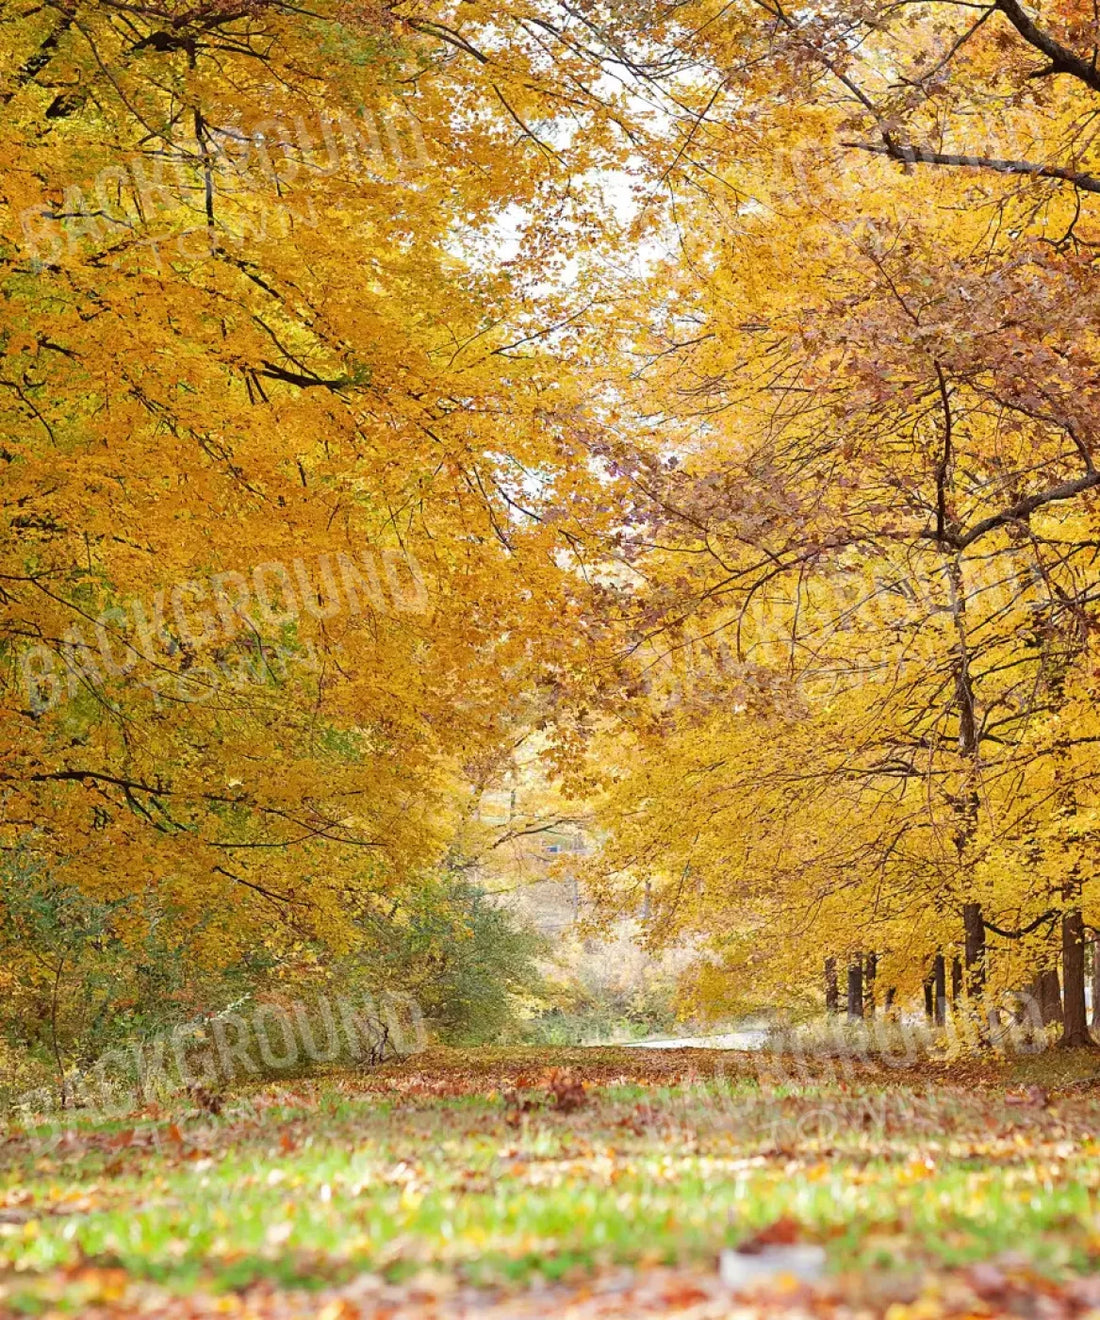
left=0, top=1049, right=1100, bottom=1312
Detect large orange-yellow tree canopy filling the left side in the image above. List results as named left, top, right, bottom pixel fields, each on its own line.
left=0, top=0, right=626, bottom=982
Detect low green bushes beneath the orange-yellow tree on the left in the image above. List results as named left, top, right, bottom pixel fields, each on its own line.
left=0, top=851, right=544, bottom=1107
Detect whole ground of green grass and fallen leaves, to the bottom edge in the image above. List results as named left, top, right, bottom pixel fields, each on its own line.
left=0, top=1048, right=1100, bottom=1320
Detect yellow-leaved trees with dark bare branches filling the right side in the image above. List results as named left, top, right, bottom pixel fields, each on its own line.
left=583, top=4, right=1096, bottom=1041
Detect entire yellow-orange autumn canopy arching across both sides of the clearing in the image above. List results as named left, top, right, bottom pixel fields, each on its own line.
left=0, top=0, right=1100, bottom=1044
